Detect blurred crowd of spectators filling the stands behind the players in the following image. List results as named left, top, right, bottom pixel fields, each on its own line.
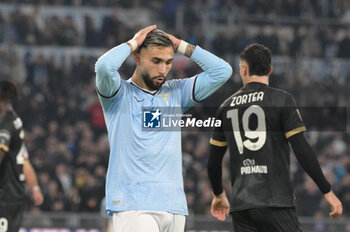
left=0, top=0, right=350, bottom=217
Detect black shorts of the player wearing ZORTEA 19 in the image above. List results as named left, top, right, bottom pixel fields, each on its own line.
left=231, top=208, right=302, bottom=232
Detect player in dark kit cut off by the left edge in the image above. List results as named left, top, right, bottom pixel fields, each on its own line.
left=0, top=80, right=44, bottom=232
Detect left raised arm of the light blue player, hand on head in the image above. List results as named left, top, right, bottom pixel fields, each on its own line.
left=95, top=25, right=156, bottom=98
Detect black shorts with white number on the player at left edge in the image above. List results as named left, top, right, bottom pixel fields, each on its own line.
left=0, top=204, right=25, bottom=232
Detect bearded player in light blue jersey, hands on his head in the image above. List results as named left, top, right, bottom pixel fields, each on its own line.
left=95, top=25, right=232, bottom=232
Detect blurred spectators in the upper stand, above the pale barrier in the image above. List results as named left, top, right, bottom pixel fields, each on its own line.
left=0, top=0, right=350, bottom=58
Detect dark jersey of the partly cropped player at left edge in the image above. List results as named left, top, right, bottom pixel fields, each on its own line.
left=0, top=111, right=28, bottom=205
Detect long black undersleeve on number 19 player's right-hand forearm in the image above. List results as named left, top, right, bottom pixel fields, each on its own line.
left=289, top=133, right=331, bottom=194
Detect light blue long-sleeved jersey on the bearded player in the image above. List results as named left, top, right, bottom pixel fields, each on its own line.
left=95, top=43, right=232, bottom=215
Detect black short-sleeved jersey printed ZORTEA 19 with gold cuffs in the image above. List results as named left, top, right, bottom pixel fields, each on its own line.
left=210, top=82, right=306, bottom=212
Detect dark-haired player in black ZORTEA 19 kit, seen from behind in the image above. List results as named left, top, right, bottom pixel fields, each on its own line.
left=208, top=44, right=342, bottom=232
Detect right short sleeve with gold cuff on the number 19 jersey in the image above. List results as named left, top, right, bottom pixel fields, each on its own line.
left=281, top=94, right=306, bottom=139
